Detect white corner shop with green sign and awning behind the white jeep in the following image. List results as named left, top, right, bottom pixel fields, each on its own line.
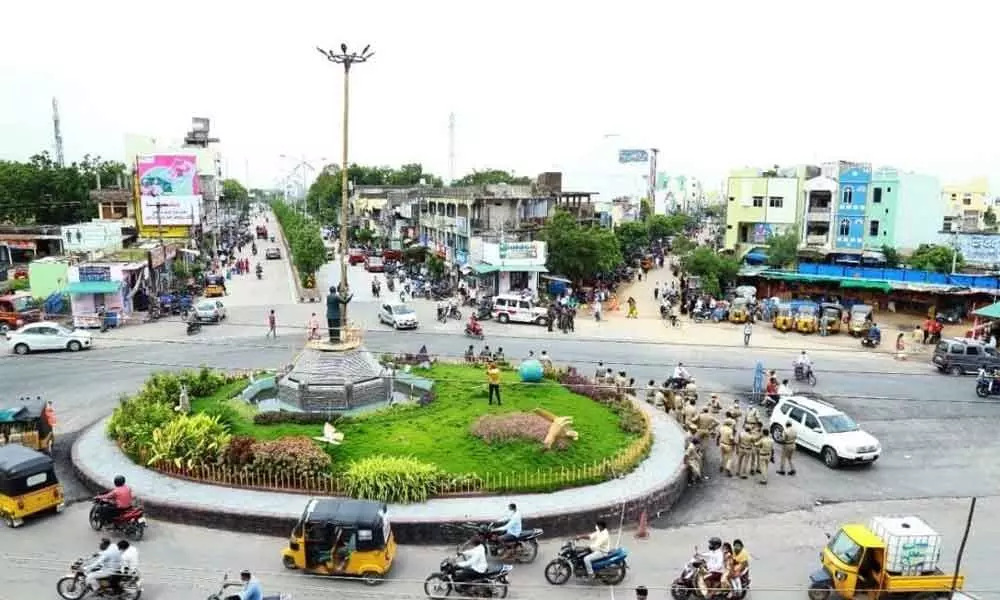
left=472, top=242, right=548, bottom=296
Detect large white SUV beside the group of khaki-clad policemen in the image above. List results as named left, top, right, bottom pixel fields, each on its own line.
left=770, top=396, right=882, bottom=469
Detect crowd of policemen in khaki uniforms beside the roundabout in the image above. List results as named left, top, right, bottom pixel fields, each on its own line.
left=646, top=378, right=797, bottom=485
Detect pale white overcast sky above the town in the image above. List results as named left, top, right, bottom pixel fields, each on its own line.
left=0, top=0, right=1000, bottom=198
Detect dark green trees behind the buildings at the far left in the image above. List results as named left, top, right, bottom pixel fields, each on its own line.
left=0, top=152, right=129, bottom=225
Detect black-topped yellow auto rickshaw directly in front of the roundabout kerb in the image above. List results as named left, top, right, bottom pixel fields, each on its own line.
left=281, top=498, right=396, bottom=585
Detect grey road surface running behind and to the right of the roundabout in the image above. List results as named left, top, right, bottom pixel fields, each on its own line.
left=0, top=211, right=1000, bottom=527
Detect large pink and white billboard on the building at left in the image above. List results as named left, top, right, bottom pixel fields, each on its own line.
left=136, top=154, right=201, bottom=227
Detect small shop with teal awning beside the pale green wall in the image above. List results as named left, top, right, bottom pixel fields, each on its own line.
left=65, top=263, right=146, bottom=327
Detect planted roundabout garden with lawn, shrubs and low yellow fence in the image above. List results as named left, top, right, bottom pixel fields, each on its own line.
left=108, top=363, right=652, bottom=503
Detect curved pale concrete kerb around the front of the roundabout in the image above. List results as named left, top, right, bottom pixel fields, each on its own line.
left=72, top=404, right=687, bottom=543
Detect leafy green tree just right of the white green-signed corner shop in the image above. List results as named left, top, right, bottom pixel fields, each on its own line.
left=540, top=211, right=622, bottom=281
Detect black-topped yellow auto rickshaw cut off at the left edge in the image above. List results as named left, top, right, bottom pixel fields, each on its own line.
left=0, top=444, right=66, bottom=527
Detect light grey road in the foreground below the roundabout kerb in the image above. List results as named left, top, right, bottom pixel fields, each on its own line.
left=0, top=499, right=1000, bottom=600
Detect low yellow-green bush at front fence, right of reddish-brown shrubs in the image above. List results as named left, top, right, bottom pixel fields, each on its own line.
left=342, top=455, right=445, bottom=503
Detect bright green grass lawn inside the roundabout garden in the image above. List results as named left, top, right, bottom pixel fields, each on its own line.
left=192, top=364, right=637, bottom=474
